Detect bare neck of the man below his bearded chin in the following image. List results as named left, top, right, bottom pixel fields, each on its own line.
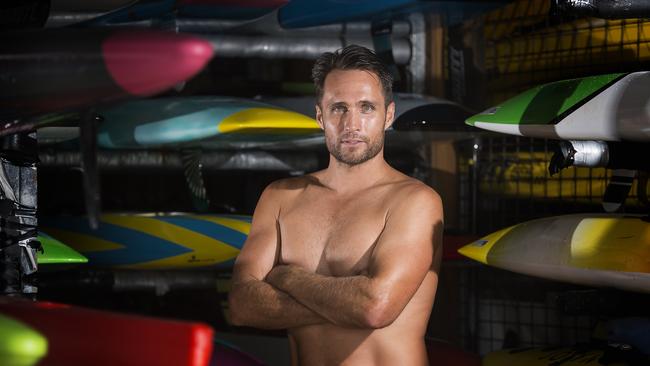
left=323, top=151, right=392, bottom=193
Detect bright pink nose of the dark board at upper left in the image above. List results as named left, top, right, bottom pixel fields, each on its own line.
left=102, top=31, right=213, bottom=96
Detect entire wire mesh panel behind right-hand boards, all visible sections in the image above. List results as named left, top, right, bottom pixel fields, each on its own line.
left=441, top=0, right=650, bottom=354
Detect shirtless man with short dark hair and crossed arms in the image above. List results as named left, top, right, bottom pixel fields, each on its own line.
left=229, top=46, right=442, bottom=366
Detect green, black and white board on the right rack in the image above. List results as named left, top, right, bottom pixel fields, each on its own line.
left=466, top=71, right=650, bottom=142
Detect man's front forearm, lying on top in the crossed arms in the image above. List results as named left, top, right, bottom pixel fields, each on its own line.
left=269, top=266, right=382, bottom=328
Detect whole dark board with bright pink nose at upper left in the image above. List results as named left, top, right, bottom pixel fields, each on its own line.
left=0, top=28, right=213, bottom=127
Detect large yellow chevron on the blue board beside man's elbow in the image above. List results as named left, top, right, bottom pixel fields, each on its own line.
left=101, top=215, right=239, bottom=268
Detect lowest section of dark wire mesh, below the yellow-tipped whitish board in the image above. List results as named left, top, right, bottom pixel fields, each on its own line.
left=456, top=263, right=597, bottom=355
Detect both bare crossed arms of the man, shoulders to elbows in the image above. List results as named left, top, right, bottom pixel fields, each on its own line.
left=229, top=187, right=442, bottom=329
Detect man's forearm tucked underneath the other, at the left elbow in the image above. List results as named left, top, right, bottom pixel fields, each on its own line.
left=228, top=280, right=326, bottom=329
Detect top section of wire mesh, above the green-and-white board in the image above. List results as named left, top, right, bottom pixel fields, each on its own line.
left=452, top=0, right=650, bottom=107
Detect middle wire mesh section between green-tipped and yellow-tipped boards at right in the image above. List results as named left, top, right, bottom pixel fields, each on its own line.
left=457, top=135, right=645, bottom=235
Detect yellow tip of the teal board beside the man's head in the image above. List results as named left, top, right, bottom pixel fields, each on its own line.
left=218, top=108, right=320, bottom=133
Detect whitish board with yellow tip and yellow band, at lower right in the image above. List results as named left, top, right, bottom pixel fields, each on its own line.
left=458, top=214, right=650, bottom=293
